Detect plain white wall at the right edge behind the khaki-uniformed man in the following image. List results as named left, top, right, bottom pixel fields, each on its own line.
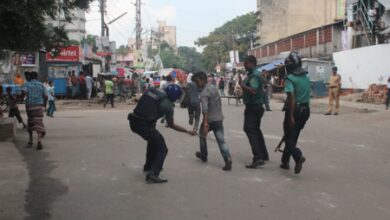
left=333, top=44, right=390, bottom=89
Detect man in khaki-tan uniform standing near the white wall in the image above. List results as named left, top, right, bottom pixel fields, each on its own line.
left=325, top=67, right=341, bottom=115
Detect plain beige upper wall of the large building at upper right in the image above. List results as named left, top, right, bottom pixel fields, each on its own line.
left=257, top=0, right=345, bottom=46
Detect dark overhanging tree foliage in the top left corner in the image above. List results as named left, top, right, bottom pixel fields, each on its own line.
left=0, top=0, right=92, bottom=51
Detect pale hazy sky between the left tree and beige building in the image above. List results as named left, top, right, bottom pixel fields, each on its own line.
left=86, top=0, right=256, bottom=50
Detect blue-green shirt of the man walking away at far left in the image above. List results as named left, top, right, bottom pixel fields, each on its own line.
left=24, top=79, right=47, bottom=106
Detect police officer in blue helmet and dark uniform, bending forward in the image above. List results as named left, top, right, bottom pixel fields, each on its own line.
left=128, top=84, right=195, bottom=183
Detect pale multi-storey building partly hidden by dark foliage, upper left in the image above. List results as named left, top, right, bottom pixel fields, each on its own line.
left=46, top=9, right=86, bottom=42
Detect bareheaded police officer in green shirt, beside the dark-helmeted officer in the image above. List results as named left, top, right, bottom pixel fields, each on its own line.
left=238, top=56, right=269, bottom=169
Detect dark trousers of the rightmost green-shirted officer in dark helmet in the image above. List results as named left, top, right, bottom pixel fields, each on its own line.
left=282, top=106, right=310, bottom=164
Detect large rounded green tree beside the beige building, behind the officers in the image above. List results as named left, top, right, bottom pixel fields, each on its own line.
left=195, top=12, right=256, bottom=70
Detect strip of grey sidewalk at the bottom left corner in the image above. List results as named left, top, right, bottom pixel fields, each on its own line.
left=0, top=142, right=29, bottom=219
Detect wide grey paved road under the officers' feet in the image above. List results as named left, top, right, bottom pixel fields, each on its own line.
left=11, top=100, right=390, bottom=220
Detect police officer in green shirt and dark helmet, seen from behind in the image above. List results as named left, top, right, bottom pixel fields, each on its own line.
left=280, top=52, right=310, bottom=174
